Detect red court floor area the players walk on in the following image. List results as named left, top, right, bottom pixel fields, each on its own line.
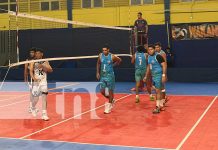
left=0, top=93, right=218, bottom=150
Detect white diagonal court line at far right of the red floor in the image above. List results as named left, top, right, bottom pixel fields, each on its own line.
left=175, top=95, right=218, bottom=150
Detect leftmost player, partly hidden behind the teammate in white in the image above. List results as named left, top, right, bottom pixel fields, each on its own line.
left=24, top=47, right=36, bottom=113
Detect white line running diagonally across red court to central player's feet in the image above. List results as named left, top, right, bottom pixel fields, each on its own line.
left=20, top=94, right=132, bottom=139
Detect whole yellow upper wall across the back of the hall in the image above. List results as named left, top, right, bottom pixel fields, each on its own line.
left=0, top=1, right=218, bottom=30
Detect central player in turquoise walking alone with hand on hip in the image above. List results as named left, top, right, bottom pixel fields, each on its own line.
left=96, top=45, right=121, bottom=114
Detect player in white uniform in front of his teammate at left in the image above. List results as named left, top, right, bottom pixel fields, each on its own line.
left=30, top=48, right=53, bottom=121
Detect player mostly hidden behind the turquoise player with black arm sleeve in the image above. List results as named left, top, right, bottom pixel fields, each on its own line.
left=155, top=42, right=168, bottom=104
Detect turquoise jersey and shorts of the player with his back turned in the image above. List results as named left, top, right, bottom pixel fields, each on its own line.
left=135, top=52, right=147, bottom=82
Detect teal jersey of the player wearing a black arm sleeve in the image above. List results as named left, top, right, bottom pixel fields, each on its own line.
left=148, top=53, right=163, bottom=75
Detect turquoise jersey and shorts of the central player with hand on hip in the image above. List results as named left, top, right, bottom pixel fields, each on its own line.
left=100, top=53, right=115, bottom=90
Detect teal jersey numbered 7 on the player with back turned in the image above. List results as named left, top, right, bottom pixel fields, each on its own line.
left=135, top=52, right=146, bottom=70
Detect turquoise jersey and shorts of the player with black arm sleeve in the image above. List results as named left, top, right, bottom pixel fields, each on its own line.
left=148, top=53, right=163, bottom=89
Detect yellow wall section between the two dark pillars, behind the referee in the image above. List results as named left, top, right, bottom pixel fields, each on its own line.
left=73, top=4, right=164, bottom=26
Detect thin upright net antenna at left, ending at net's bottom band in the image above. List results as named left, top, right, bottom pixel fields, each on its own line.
left=16, top=0, right=20, bottom=62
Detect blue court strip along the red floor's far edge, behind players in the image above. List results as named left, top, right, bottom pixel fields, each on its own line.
left=1, top=82, right=218, bottom=96
